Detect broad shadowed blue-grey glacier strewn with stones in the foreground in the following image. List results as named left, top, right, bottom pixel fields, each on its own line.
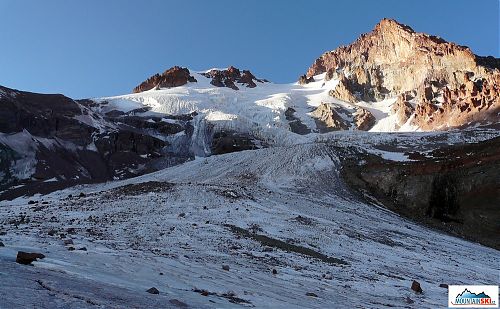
left=0, top=142, right=499, bottom=308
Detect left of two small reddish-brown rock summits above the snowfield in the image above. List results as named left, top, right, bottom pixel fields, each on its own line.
left=133, top=66, right=196, bottom=93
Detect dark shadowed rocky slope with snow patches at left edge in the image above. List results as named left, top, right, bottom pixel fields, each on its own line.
left=0, top=87, right=194, bottom=199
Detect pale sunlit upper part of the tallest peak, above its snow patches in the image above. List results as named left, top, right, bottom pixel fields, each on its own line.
left=307, top=19, right=477, bottom=100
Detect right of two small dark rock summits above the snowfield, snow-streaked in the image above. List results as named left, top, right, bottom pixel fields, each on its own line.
left=202, top=66, right=265, bottom=90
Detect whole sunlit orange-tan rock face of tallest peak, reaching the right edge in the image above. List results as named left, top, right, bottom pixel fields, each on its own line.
left=305, top=19, right=500, bottom=130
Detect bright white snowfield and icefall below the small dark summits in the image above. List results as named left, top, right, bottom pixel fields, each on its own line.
left=95, top=71, right=417, bottom=150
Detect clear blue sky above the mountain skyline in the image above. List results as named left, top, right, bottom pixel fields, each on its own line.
left=0, top=0, right=499, bottom=98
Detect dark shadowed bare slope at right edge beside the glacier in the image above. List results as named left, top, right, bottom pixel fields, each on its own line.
left=342, top=137, right=500, bottom=249
